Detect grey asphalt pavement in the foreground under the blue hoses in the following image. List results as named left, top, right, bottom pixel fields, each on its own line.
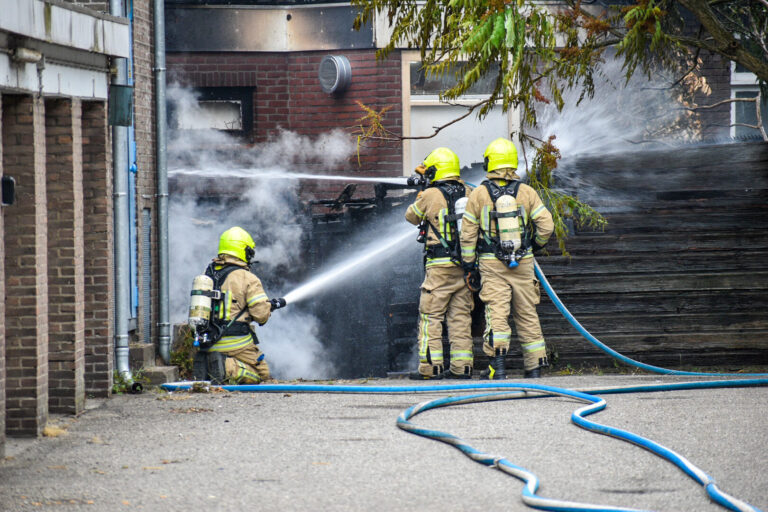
left=0, top=375, right=768, bottom=512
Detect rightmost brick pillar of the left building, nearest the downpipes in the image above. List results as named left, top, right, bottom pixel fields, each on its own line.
left=82, top=101, right=115, bottom=397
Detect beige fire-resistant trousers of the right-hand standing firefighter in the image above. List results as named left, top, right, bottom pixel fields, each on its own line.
left=479, top=258, right=547, bottom=370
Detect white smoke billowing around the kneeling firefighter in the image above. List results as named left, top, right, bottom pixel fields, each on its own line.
left=168, top=86, right=355, bottom=378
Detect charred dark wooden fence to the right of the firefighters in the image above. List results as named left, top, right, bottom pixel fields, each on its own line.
left=539, top=143, right=768, bottom=368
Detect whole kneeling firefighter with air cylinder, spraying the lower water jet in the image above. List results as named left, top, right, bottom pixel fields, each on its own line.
left=189, top=227, right=285, bottom=384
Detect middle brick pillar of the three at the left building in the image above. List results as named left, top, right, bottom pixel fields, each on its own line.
left=45, top=98, right=85, bottom=414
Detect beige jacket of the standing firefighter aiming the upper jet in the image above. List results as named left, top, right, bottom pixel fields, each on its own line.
left=405, top=178, right=472, bottom=267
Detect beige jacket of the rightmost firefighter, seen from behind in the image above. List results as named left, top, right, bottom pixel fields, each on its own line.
left=461, top=169, right=555, bottom=262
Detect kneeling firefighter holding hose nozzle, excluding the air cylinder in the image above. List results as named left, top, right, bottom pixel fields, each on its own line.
left=195, top=226, right=285, bottom=384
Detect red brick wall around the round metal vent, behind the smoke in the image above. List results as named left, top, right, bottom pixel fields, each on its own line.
left=168, top=50, right=402, bottom=197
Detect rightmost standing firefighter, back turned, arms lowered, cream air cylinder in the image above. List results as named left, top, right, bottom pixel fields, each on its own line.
left=461, top=138, right=554, bottom=379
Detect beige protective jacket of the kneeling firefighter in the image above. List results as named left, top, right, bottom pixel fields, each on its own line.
left=211, top=254, right=272, bottom=352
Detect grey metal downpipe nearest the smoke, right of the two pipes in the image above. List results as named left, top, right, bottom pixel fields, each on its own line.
left=154, top=0, right=171, bottom=365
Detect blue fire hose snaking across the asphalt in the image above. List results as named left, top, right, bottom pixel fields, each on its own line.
left=161, top=260, right=768, bottom=512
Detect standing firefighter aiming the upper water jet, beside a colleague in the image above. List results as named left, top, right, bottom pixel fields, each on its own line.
left=405, top=148, right=474, bottom=379
